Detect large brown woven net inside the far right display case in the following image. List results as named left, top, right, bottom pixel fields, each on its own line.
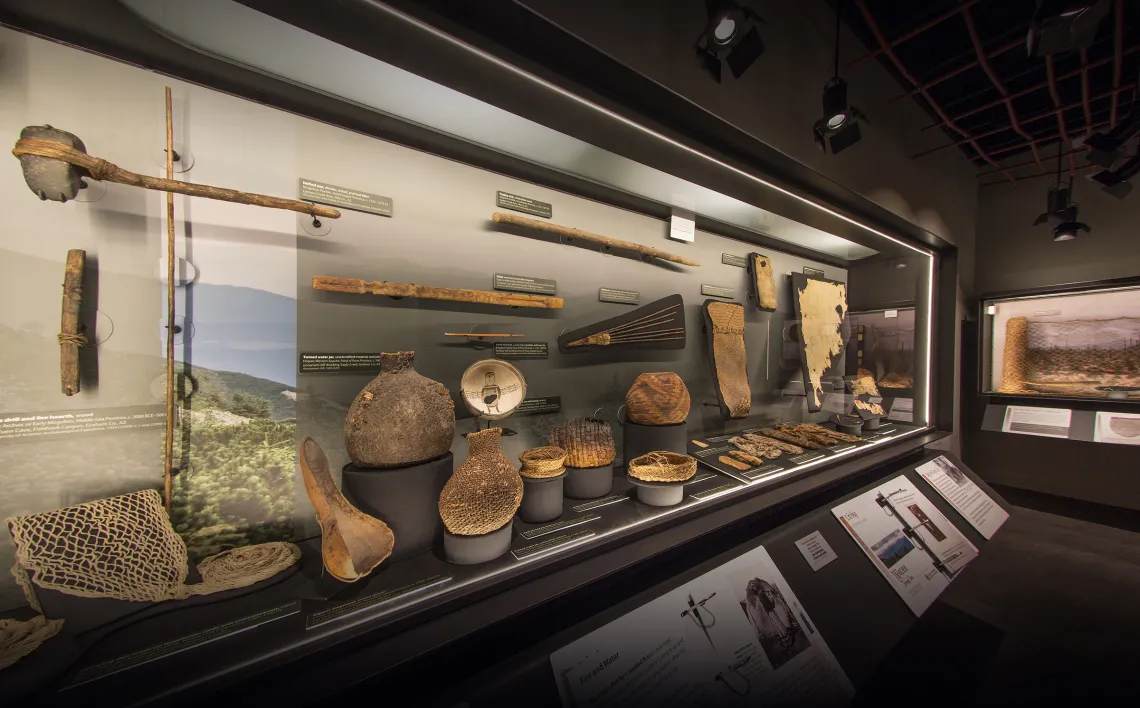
left=999, top=317, right=1140, bottom=394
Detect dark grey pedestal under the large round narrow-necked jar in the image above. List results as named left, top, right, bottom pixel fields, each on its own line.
left=341, top=453, right=455, bottom=562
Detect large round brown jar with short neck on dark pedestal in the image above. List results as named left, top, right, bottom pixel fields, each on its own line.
left=344, top=351, right=455, bottom=467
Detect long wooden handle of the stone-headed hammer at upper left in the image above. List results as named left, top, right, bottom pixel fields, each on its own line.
left=11, top=138, right=341, bottom=219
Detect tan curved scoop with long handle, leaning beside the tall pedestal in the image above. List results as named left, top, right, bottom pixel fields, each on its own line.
left=301, top=438, right=396, bottom=583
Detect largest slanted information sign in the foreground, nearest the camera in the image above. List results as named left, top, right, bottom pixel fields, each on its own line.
left=551, top=547, right=855, bottom=708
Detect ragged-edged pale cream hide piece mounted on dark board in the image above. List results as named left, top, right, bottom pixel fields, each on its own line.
left=791, top=272, right=847, bottom=413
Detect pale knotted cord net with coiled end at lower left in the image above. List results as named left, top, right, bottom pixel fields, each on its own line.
left=8, top=489, right=300, bottom=609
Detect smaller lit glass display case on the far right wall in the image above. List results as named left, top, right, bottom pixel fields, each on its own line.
left=980, top=283, right=1140, bottom=401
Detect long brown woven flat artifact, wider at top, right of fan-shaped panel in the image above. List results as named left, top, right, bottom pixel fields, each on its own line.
left=702, top=300, right=752, bottom=418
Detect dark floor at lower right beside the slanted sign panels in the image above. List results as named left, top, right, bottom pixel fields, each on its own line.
left=857, top=499, right=1140, bottom=706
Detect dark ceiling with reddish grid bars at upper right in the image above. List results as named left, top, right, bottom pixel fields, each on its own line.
left=838, top=0, right=1140, bottom=185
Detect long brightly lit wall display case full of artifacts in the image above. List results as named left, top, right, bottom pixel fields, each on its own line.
left=0, top=0, right=957, bottom=690
